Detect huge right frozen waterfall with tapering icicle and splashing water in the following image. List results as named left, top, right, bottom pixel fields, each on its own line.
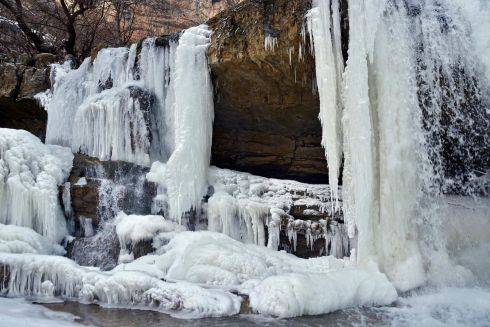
left=308, top=0, right=489, bottom=291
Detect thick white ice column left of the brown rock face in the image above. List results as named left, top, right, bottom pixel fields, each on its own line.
left=165, top=25, right=214, bottom=222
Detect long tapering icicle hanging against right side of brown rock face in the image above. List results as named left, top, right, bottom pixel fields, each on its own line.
left=307, top=0, right=344, bottom=208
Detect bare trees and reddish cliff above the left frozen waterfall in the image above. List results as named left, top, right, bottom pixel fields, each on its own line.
left=0, top=0, right=239, bottom=60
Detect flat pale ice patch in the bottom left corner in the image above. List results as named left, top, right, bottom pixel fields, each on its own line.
left=0, top=298, right=82, bottom=327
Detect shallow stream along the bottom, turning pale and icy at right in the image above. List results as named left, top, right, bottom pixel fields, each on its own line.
left=35, top=288, right=490, bottom=327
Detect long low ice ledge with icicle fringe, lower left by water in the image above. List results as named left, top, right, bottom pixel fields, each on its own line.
left=0, top=254, right=241, bottom=317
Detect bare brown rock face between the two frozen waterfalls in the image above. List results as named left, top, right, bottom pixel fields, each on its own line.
left=208, top=0, right=328, bottom=183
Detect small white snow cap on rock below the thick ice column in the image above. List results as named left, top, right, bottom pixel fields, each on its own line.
left=115, top=211, right=187, bottom=262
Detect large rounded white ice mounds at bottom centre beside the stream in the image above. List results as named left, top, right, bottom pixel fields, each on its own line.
left=126, top=232, right=397, bottom=317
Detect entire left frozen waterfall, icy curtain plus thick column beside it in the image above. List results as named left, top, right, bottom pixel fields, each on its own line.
left=43, top=25, right=214, bottom=226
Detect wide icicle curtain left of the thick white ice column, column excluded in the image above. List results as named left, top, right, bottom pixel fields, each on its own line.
left=38, top=39, right=175, bottom=165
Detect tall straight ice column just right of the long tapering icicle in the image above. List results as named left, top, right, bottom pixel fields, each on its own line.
left=342, top=1, right=377, bottom=261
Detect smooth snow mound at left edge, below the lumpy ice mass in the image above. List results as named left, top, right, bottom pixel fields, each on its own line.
left=0, top=224, right=65, bottom=255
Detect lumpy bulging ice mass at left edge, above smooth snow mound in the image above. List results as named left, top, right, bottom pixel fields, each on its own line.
left=0, top=128, right=73, bottom=243
